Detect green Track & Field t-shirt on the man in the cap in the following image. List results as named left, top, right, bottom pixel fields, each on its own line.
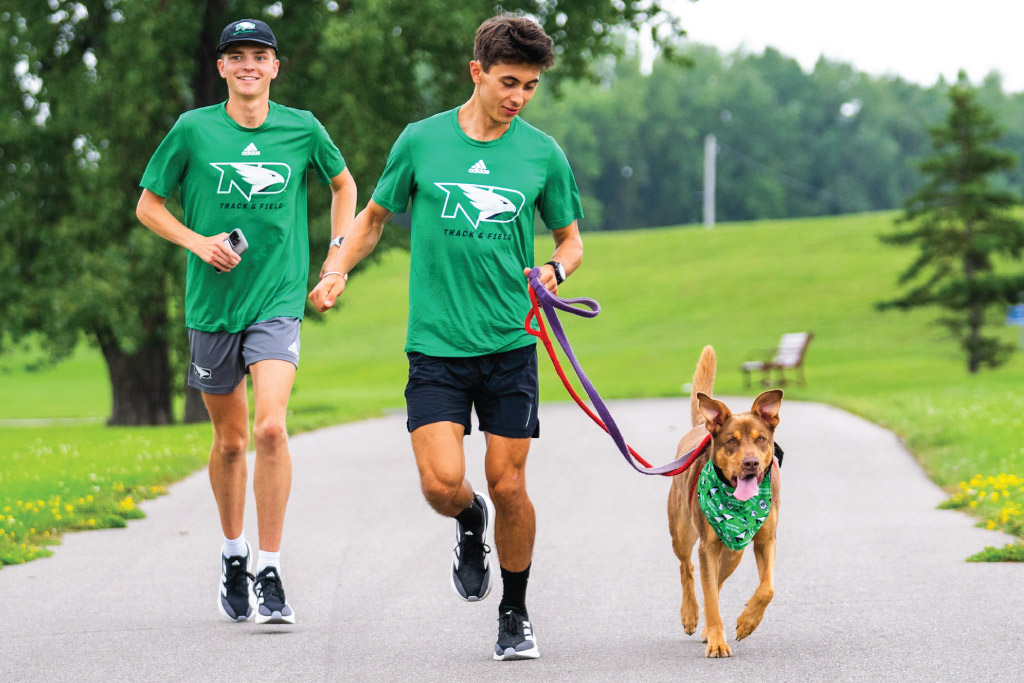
left=139, top=101, right=345, bottom=332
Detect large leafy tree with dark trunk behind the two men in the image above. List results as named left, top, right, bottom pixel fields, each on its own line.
left=0, top=0, right=681, bottom=424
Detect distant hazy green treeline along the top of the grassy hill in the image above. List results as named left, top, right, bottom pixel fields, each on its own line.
left=526, top=46, right=1024, bottom=229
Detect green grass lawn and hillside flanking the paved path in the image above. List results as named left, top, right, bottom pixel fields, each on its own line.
left=0, top=214, right=1024, bottom=562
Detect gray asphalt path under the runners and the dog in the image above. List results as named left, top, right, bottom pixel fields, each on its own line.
left=0, top=399, right=1024, bottom=683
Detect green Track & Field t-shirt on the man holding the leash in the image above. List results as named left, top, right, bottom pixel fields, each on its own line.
left=374, top=109, right=583, bottom=356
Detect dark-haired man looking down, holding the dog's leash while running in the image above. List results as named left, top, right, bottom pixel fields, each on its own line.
left=309, top=15, right=583, bottom=659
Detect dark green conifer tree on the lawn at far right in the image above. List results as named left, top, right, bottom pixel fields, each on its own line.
left=879, top=72, right=1024, bottom=373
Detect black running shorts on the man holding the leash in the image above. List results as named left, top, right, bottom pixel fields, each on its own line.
left=406, top=344, right=541, bottom=438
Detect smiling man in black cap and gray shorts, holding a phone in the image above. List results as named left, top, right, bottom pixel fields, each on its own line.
left=136, top=18, right=355, bottom=624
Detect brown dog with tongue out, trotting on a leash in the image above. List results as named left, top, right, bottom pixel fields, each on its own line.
left=669, top=346, right=782, bottom=657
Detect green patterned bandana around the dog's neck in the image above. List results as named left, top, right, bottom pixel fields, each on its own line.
left=697, top=458, right=771, bottom=550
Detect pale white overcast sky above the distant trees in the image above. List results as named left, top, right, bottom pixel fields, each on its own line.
left=668, top=0, right=1024, bottom=92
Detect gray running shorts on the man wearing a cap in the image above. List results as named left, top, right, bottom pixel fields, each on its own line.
left=188, top=317, right=302, bottom=393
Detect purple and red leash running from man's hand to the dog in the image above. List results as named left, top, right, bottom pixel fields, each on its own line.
left=524, top=267, right=711, bottom=476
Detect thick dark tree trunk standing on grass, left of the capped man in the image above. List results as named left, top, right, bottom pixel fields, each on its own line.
left=97, top=327, right=172, bottom=426
